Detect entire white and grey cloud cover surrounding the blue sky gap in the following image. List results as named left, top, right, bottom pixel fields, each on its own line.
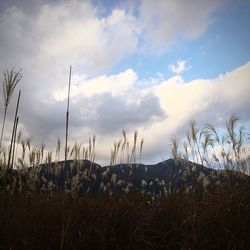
left=0, top=0, right=250, bottom=165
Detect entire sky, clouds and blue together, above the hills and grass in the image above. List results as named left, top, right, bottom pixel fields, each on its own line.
left=0, top=0, right=250, bottom=164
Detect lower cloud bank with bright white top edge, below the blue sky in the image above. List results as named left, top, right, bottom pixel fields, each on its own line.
left=0, top=59, right=250, bottom=163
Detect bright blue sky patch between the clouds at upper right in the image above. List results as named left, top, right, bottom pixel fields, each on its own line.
left=111, top=0, right=250, bottom=81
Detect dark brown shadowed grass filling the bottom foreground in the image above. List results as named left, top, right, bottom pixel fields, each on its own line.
left=0, top=183, right=250, bottom=250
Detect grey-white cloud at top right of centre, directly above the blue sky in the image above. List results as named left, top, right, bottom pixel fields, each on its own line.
left=139, top=0, right=221, bottom=52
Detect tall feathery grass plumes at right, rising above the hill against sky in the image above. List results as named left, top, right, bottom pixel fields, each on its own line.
left=172, top=114, right=250, bottom=174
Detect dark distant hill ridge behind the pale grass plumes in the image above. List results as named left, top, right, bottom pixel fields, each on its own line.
left=0, top=159, right=250, bottom=198
